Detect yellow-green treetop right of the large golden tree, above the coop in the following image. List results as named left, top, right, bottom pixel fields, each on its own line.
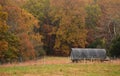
left=86, top=3, right=101, bottom=28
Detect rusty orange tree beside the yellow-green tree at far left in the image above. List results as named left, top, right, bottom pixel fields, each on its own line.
left=4, top=0, right=41, bottom=60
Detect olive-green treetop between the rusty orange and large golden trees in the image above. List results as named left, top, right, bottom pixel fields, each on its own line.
left=23, top=0, right=50, bottom=21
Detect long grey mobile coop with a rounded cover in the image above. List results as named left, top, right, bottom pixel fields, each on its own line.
left=70, top=48, right=106, bottom=62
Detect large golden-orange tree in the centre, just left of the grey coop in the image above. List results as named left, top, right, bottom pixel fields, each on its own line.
left=49, top=0, right=87, bottom=55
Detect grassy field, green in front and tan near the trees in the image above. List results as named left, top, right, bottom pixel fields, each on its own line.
left=0, top=57, right=120, bottom=76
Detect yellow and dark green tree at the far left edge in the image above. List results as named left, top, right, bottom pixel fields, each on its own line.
left=0, top=6, right=19, bottom=63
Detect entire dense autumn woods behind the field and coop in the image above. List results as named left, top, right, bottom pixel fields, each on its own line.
left=0, top=0, right=120, bottom=63
